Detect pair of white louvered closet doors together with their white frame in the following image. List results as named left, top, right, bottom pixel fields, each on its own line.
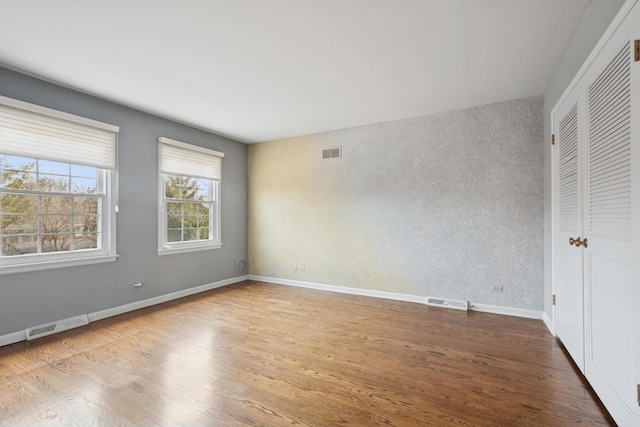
left=552, top=1, right=640, bottom=426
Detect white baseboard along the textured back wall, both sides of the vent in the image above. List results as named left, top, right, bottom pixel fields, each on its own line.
left=248, top=275, right=542, bottom=320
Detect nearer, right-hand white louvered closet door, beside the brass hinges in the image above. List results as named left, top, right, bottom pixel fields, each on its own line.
left=583, top=7, right=640, bottom=426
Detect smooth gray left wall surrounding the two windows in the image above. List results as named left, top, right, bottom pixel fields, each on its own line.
left=0, top=68, right=247, bottom=335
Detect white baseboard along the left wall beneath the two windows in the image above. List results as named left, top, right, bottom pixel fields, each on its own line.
left=0, top=276, right=249, bottom=347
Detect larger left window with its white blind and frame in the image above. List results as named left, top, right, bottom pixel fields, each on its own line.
left=0, top=97, right=118, bottom=274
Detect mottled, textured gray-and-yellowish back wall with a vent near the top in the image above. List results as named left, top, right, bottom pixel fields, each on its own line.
left=249, top=97, right=543, bottom=311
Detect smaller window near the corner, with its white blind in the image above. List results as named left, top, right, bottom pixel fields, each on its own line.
left=158, top=138, right=224, bottom=255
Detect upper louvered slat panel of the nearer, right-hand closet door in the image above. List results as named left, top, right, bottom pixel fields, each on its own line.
left=588, top=43, right=631, bottom=240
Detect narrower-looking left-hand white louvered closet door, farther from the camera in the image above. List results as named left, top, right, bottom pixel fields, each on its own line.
left=555, top=98, right=584, bottom=372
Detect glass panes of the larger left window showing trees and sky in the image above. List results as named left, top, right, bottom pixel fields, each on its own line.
left=0, top=155, right=102, bottom=257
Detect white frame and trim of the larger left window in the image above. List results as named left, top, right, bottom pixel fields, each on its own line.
left=0, top=96, right=119, bottom=275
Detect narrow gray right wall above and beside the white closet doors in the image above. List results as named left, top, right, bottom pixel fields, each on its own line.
left=544, top=0, right=624, bottom=318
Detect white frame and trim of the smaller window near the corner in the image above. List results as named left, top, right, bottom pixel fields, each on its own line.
left=157, top=137, right=224, bottom=255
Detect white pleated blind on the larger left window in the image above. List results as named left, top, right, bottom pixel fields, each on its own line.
left=0, top=96, right=119, bottom=170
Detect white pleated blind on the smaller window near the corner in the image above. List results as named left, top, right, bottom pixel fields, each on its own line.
left=158, top=137, right=224, bottom=181
